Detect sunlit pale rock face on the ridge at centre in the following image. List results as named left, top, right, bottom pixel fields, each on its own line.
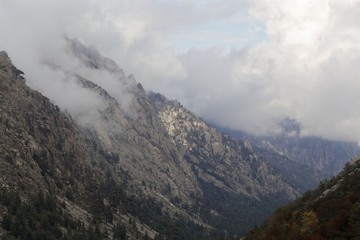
left=150, top=94, right=296, bottom=200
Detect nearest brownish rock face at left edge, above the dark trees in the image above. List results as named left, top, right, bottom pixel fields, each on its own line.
left=0, top=52, right=93, bottom=193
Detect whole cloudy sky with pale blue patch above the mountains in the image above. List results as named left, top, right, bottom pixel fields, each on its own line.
left=0, top=0, right=360, bottom=141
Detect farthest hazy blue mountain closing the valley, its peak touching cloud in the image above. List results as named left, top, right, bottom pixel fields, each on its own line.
left=220, top=118, right=360, bottom=187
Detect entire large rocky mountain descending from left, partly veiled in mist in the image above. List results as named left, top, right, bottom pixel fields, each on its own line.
left=0, top=38, right=299, bottom=239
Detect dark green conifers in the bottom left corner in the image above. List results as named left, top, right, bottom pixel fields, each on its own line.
left=0, top=190, right=103, bottom=240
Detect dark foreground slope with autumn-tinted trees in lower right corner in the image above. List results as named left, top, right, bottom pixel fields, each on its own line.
left=243, top=157, right=360, bottom=240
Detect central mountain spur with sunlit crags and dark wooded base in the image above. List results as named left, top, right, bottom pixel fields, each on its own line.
left=150, top=93, right=299, bottom=233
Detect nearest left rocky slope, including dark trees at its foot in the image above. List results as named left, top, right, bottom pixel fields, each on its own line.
left=0, top=52, right=115, bottom=239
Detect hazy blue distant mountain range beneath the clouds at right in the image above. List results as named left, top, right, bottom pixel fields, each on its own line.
left=221, top=118, right=360, bottom=181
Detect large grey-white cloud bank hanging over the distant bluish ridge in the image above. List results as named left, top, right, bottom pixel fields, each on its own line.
left=169, top=0, right=360, bottom=140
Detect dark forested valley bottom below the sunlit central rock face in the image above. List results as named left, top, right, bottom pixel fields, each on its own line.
left=200, top=181, right=288, bottom=237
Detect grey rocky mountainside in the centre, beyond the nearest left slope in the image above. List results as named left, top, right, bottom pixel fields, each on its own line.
left=64, top=40, right=298, bottom=237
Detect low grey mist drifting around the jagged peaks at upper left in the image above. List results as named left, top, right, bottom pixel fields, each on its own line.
left=0, top=1, right=139, bottom=126
